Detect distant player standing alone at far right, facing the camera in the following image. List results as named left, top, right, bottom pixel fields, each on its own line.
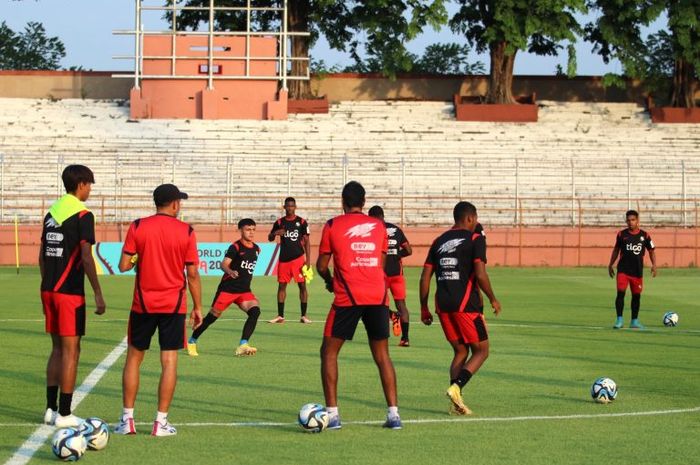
left=608, top=210, right=656, bottom=329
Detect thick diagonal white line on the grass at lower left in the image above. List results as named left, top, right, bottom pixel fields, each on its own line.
left=5, top=337, right=127, bottom=465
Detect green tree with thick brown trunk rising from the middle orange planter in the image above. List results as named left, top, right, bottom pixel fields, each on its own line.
left=449, top=0, right=587, bottom=103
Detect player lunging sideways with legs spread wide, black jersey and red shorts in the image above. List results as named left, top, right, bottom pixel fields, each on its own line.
left=187, top=218, right=260, bottom=357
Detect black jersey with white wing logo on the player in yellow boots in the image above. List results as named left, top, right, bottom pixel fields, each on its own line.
left=424, top=228, right=486, bottom=313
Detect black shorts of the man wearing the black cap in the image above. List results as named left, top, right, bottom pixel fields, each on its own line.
left=129, top=312, right=187, bottom=350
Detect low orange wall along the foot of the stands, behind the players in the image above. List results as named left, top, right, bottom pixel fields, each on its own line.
left=0, top=225, right=700, bottom=267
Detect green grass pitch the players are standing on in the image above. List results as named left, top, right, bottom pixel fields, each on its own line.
left=0, top=268, right=700, bottom=465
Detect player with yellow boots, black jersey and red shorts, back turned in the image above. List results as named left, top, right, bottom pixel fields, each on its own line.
left=420, top=202, right=501, bottom=415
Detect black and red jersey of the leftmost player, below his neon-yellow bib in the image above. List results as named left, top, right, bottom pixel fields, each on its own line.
left=41, top=204, right=95, bottom=295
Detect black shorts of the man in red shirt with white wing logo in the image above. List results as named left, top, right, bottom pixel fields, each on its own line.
left=323, top=305, right=389, bottom=341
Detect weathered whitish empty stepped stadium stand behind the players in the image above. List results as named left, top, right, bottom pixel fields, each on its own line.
left=0, top=99, right=700, bottom=225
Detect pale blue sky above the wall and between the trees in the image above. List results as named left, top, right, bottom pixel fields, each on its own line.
left=0, top=0, right=665, bottom=76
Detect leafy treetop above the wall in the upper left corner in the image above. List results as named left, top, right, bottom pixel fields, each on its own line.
left=0, top=21, right=66, bottom=69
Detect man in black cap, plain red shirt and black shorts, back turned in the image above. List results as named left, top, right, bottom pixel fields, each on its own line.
left=115, top=184, right=202, bottom=436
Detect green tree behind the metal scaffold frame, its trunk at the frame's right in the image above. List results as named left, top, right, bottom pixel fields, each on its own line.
left=166, top=0, right=447, bottom=98
